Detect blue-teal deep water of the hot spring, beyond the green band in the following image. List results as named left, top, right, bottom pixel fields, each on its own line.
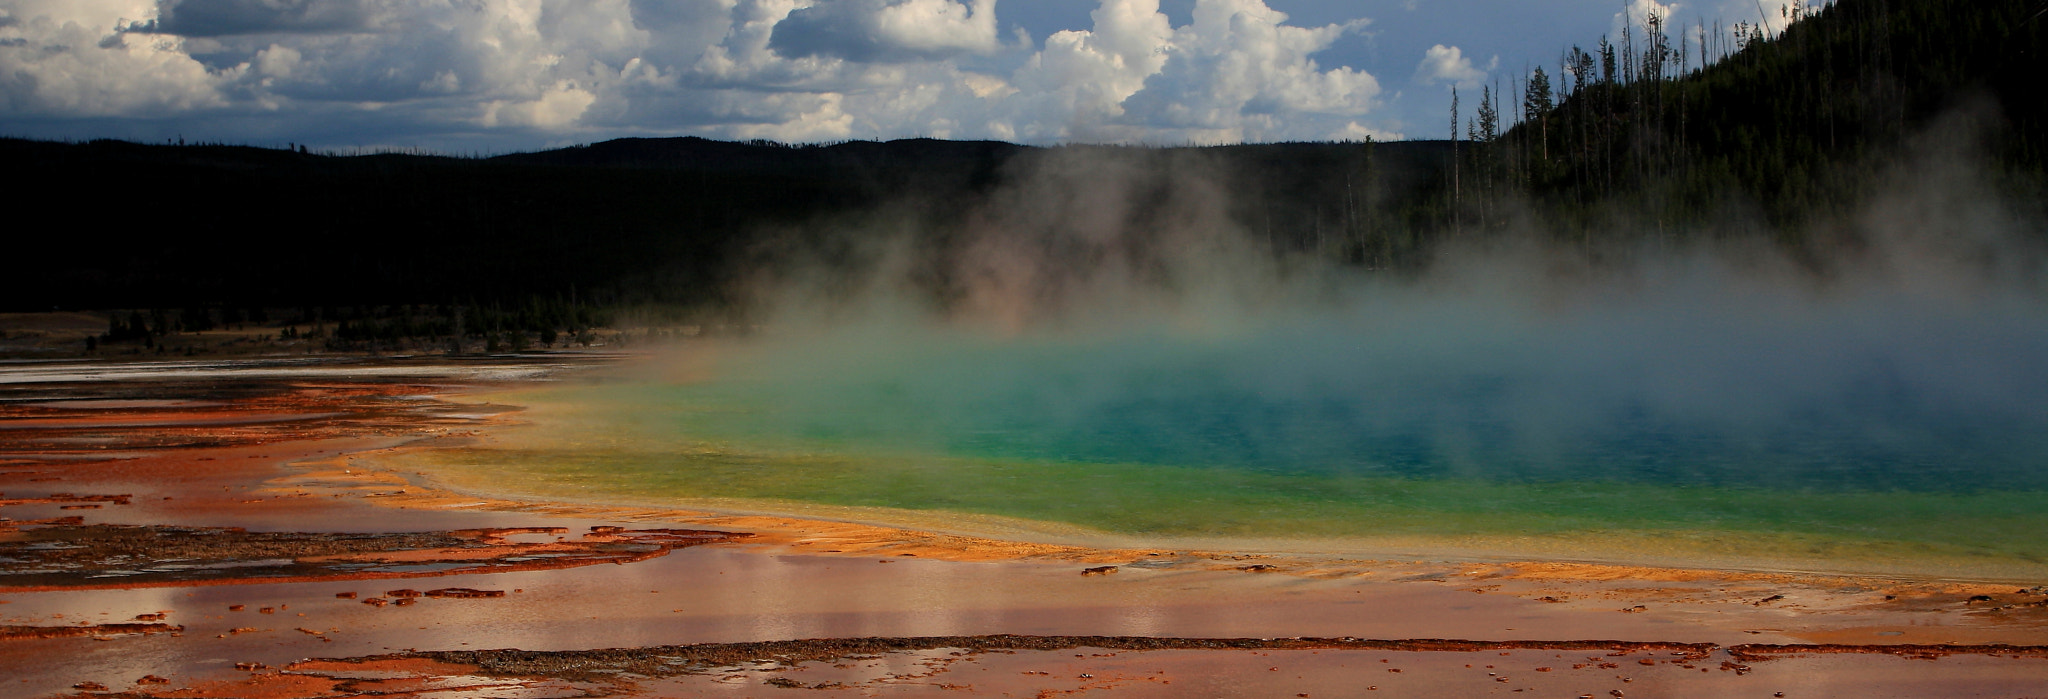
left=712, top=313, right=2048, bottom=492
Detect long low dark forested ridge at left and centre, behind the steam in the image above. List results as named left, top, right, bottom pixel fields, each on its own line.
left=0, top=137, right=1450, bottom=310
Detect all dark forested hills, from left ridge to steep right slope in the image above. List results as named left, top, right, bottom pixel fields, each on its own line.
left=0, top=0, right=2048, bottom=317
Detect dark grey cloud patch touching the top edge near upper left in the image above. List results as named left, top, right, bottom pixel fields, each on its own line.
left=129, top=0, right=381, bottom=37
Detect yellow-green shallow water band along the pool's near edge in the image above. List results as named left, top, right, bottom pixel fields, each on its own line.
left=424, top=434, right=2048, bottom=570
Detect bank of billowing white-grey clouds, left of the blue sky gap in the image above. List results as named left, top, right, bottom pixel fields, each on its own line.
left=0, top=0, right=1380, bottom=143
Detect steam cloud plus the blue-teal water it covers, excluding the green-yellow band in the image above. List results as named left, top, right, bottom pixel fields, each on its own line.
left=638, top=116, right=2048, bottom=490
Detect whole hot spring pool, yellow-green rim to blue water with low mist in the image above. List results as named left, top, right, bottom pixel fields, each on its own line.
left=403, top=239, right=2048, bottom=576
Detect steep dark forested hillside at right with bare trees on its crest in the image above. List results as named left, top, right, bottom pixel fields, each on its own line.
left=1466, top=0, right=2048, bottom=238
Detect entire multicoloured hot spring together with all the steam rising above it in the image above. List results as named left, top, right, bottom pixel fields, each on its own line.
left=419, top=145, right=2048, bottom=574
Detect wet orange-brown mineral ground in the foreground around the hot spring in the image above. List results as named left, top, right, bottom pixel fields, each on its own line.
left=0, top=357, right=2048, bottom=697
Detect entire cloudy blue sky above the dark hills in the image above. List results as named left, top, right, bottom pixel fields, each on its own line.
left=0, top=0, right=1792, bottom=154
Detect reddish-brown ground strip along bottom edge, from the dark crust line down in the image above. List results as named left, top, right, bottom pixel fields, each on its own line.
left=44, top=635, right=2048, bottom=699
